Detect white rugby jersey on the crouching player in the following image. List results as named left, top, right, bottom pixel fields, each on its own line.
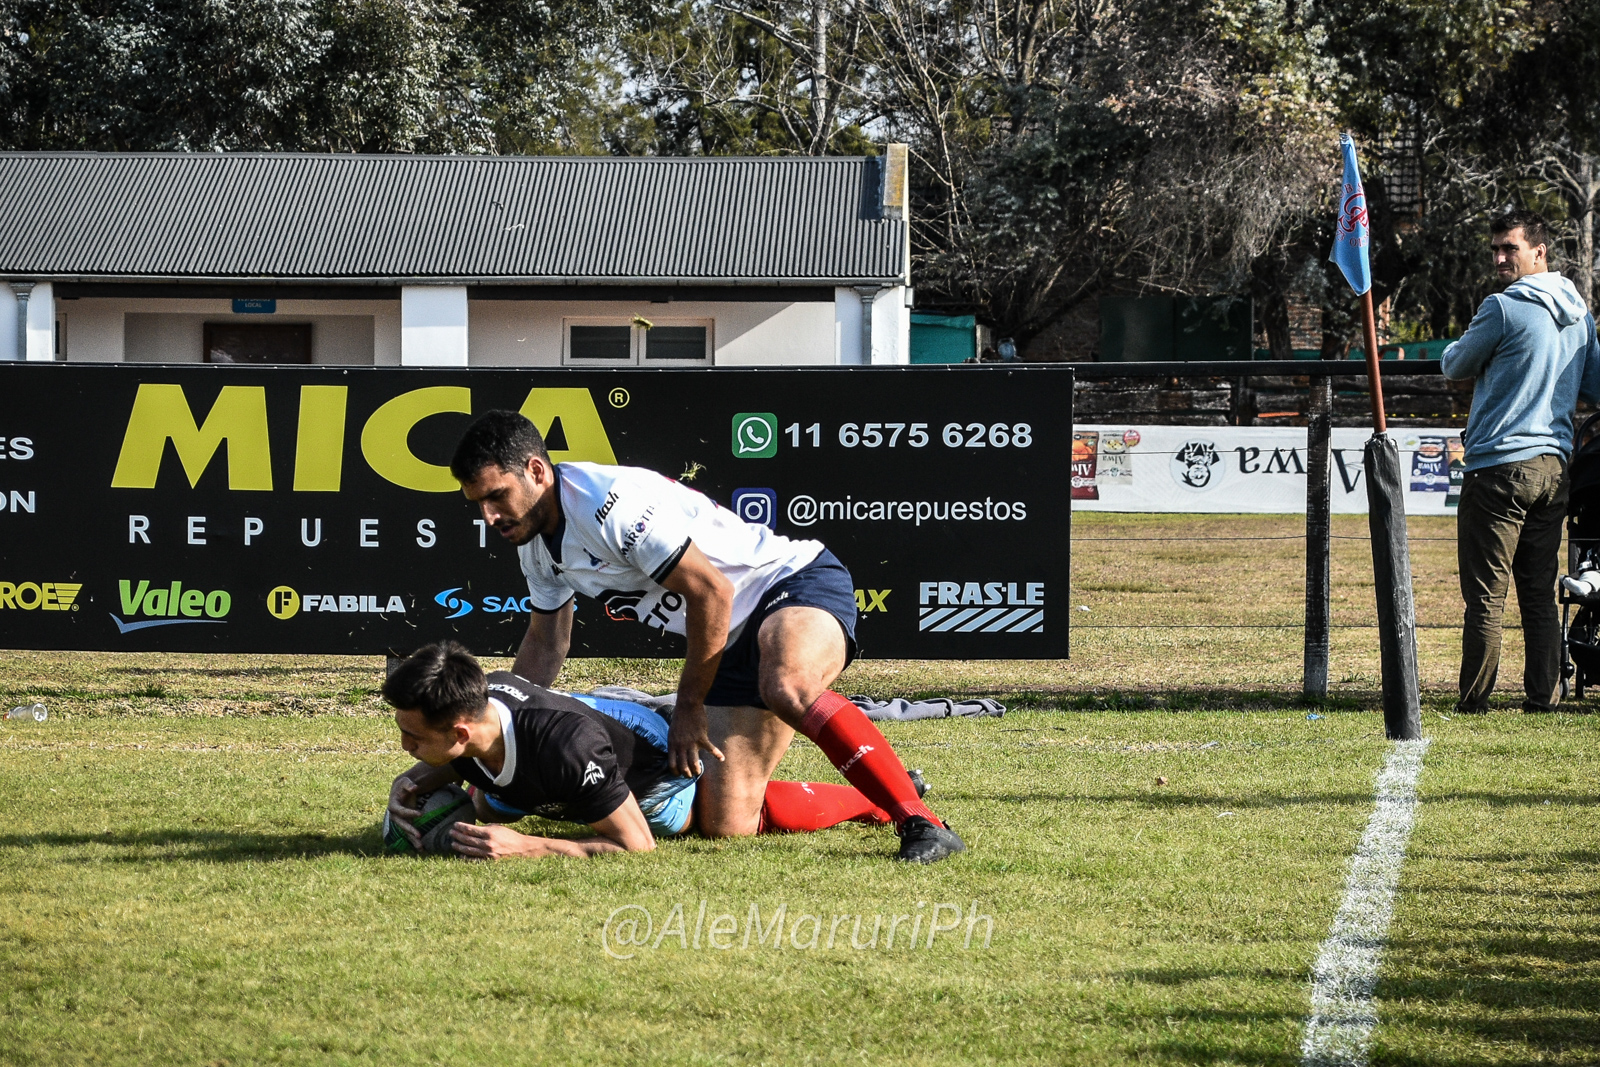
left=517, top=462, right=822, bottom=641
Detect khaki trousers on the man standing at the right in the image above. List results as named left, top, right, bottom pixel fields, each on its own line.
left=1456, top=456, right=1566, bottom=712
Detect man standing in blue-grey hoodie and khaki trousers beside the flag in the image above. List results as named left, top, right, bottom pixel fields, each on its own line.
left=1443, top=211, right=1600, bottom=715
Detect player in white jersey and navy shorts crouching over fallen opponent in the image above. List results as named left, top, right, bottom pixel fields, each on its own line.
left=450, top=411, right=965, bottom=864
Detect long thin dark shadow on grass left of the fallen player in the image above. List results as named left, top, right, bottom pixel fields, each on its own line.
left=0, top=829, right=386, bottom=864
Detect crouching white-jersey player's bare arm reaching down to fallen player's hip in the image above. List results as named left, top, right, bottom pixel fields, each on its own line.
left=661, top=542, right=733, bottom=777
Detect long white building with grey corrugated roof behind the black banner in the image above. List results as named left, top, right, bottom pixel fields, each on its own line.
left=0, top=146, right=910, bottom=366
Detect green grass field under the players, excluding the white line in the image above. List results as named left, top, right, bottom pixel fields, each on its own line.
left=0, top=517, right=1600, bottom=1065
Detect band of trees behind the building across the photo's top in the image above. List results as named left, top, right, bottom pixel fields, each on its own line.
left=0, top=0, right=1600, bottom=347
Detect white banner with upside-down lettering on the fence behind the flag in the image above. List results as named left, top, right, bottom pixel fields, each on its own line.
left=1072, top=426, right=1464, bottom=515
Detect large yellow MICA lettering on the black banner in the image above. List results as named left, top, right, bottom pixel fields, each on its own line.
left=110, top=384, right=616, bottom=493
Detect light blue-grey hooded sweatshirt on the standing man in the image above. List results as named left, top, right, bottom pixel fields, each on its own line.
left=1442, top=270, right=1600, bottom=470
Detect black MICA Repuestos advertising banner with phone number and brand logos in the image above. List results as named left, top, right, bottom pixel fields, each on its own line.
left=0, top=363, right=1072, bottom=659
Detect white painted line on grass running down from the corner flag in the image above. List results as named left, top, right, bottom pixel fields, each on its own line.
left=1301, top=741, right=1427, bottom=1067
